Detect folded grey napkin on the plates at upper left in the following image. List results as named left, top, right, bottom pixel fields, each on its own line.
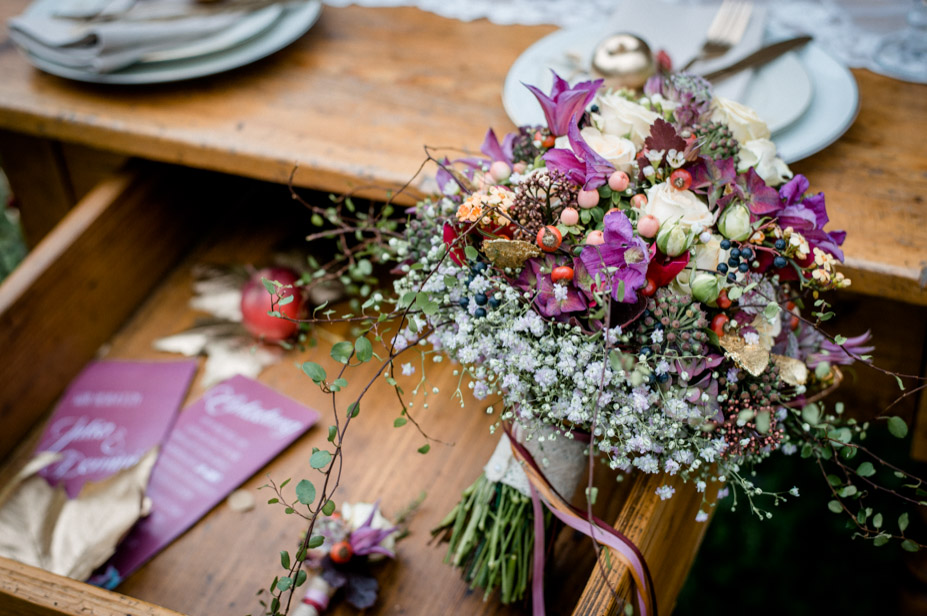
left=8, top=0, right=253, bottom=73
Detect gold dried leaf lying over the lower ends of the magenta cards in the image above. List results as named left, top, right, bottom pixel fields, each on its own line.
left=0, top=448, right=157, bottom=580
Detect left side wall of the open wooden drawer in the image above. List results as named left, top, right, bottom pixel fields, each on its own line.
left=0, top=164, right=226, bottom=457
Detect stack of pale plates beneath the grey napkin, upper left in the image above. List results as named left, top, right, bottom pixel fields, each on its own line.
left=8, top=0, right=322, bottom=84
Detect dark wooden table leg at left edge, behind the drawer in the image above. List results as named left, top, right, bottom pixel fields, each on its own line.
left=0, top=130, right=77, bottom=247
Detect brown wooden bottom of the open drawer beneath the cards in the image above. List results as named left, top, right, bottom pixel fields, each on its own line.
left=0, top=179, right=701, bottom=616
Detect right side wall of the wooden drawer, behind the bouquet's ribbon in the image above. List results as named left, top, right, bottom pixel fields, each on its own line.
left=573, top=474, right=708, bottom=616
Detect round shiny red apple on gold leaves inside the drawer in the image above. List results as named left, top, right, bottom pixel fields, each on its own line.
left=241, top=267, right=303, bottom=342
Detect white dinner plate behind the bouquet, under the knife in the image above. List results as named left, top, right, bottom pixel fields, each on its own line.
left=502, top=26, right=858, bottom=162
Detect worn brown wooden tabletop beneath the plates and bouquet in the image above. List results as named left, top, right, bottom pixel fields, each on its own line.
left=0, top=0, right=927, bottom=305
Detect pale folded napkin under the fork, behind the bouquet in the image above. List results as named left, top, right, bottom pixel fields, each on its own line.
left=595, top=0, right=766, bottom=100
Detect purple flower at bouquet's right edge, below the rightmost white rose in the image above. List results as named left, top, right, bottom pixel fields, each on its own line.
left=776, top=175, right=847, bottom=261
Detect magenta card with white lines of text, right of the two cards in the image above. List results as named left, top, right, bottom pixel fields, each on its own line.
left=109, top=376, right=319, bottom=579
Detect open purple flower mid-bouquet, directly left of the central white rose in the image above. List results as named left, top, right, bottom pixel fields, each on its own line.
left=579, top=212, right=650, bottom=303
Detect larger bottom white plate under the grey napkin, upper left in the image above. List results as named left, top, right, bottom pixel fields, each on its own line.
left=20, top=0, right=322, bottom=84
